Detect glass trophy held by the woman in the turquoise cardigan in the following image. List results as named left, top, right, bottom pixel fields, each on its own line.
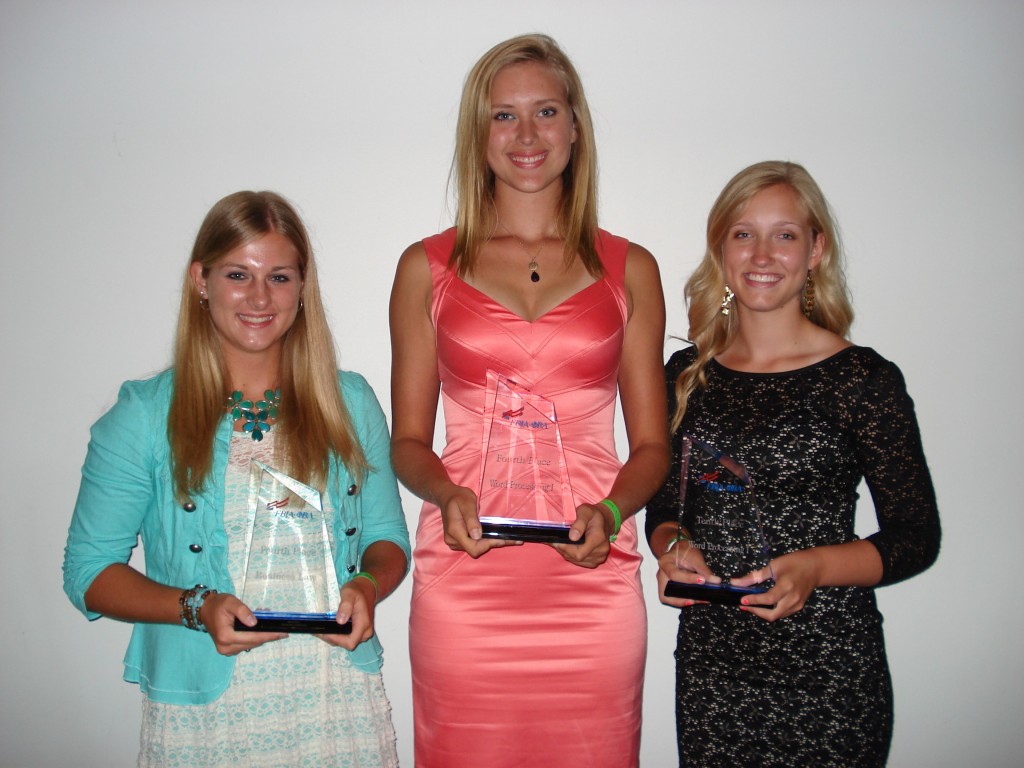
left=234, top=461, right=352, bottom=635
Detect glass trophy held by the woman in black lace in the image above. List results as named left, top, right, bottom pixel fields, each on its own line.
left=665, top=435, right=774, bottom=605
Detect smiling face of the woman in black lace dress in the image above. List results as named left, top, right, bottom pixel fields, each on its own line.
left=722, top=184, right=824, bottom=313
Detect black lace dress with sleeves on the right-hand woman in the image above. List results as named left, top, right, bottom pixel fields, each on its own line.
left=646, top=347, right=940, bottom=767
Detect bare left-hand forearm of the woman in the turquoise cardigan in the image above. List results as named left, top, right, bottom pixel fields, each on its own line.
left=85, top=563, right=187, bottom=624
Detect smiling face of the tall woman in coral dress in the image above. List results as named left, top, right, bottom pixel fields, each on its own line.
left=487, top=61, right=577, bottom=194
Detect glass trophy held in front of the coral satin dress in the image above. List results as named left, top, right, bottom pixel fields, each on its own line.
left=477, top=371, right=583, bottom=544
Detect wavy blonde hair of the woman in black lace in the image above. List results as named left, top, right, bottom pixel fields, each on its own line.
left=672, top=161, right=853, bottom=431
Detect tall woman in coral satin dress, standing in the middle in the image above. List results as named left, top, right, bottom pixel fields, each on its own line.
left=391, top=36, right=669, bottom=768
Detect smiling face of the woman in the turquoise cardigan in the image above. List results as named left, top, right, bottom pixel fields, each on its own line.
left=189, top=232, right=302, bottom=369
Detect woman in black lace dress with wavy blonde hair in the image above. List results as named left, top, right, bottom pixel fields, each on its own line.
left=647, top=162, right=940, bottom=766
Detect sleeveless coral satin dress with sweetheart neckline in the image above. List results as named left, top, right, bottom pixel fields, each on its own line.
left=410, top=229, right=647, bottom=768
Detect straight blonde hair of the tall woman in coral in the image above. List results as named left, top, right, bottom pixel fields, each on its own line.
left=450, top=35, right=603, bottom=278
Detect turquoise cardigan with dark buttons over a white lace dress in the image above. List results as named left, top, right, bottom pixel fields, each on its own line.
left=63, top=370, right=411, bottom=705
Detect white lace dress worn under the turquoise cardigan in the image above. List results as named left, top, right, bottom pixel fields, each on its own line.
left=138, top=430, right=398, bottom=768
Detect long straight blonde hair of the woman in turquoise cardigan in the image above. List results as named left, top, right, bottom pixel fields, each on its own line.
left=167, top=191, right=368, bottom=499
